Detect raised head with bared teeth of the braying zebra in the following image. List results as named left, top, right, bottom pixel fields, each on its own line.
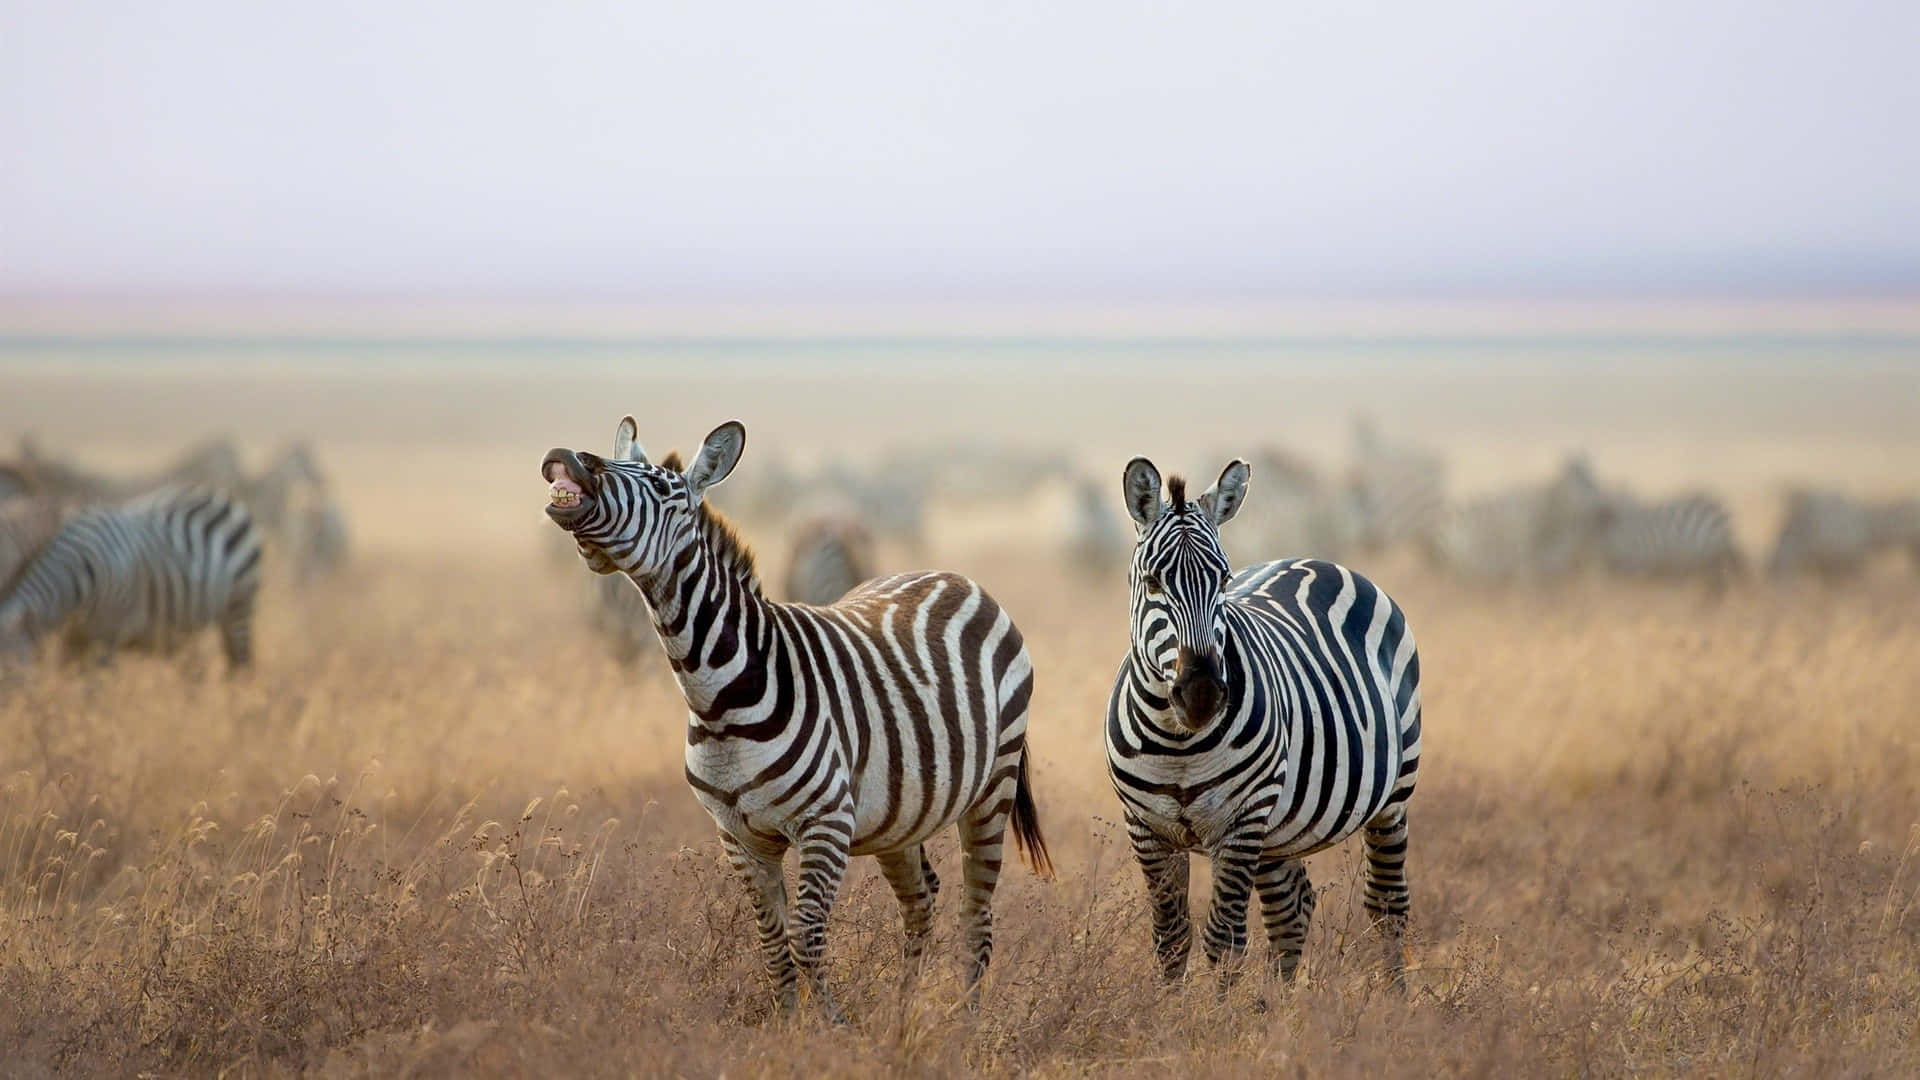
left=540, top=417, right=747, bottom=578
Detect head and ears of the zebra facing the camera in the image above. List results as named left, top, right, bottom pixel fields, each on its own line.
left=1123, top=449, right=1252, bottom=730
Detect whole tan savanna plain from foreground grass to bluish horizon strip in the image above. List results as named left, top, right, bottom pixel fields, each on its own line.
left=0, top=349, right=1920, bottom=1076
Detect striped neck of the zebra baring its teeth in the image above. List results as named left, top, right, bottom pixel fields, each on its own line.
left=630, top=544, right=774, bottom=726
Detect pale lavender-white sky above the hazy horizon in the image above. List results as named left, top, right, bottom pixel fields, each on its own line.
left=0, top=0, right=1920, bottom=300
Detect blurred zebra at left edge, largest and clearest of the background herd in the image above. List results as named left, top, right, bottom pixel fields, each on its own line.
left=0, top=488, right=261, bottom=673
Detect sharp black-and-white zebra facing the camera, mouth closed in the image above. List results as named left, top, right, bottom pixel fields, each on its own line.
left=1106, top=457, right=1421, bottom=995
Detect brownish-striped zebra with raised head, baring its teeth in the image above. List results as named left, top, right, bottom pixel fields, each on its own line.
left=541, top=417, right=1052, bottom=1019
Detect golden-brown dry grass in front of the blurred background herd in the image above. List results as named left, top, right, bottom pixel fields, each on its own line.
left=0, top=365, right=1920, bottom=1076
